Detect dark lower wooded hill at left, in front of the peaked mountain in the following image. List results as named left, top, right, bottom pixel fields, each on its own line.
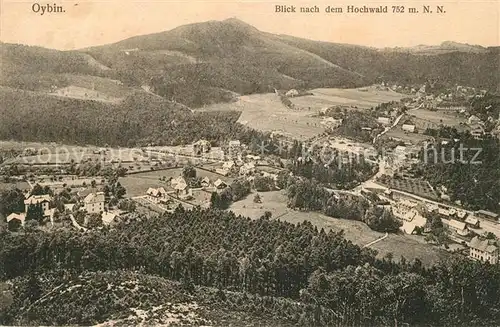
left=0, top=89, right=270, bottom=146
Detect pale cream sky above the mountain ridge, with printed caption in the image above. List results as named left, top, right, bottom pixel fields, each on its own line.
left=0, top=0, right=500, bottom=50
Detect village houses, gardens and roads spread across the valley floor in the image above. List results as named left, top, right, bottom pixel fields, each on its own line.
left=3, top=83, right=500, bottom=263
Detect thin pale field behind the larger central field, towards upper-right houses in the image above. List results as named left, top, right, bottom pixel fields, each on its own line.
left=290, top=87, right=407, bottom=111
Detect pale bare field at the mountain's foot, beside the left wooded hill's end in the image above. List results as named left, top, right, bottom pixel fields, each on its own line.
left=200, top=93, right=324, bottom=139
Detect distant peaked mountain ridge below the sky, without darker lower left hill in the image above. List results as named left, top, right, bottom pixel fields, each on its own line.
left=0, top=19, right=500, bottom=106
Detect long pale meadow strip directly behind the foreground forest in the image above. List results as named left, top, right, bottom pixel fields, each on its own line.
left=230, top=191, right=447, bottom=266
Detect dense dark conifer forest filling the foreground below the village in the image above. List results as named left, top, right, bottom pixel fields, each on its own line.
left=0, top=207, right=500, bottom=326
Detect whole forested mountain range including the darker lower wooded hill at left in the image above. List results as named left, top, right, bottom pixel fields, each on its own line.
left=0, top=19, right=500, bottom=146
